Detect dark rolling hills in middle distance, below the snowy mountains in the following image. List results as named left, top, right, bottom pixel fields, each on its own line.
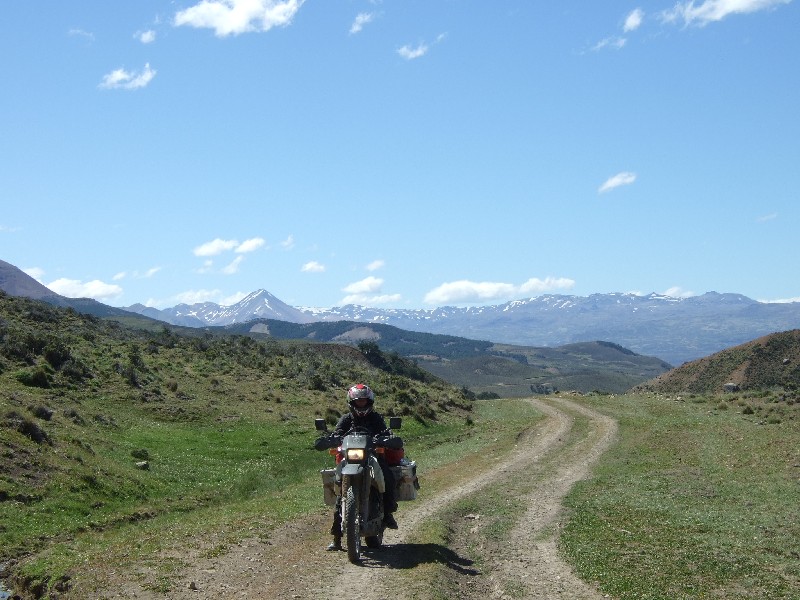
left=222, top=319, right=671, bottom=397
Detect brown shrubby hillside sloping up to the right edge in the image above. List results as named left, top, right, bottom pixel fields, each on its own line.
left=635, top=329, right=800, bottom=395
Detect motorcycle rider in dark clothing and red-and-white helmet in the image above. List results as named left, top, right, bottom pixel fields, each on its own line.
left=316, top=383, right=397, bottom=550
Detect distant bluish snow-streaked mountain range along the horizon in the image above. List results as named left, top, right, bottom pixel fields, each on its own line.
left=0, top=255, right=800, bottom=365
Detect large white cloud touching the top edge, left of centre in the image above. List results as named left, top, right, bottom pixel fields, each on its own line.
left=174, top=0, right=305, bottom=37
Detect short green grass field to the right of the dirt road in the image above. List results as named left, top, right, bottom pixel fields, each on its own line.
left=561, top=395, right=800, bottom=599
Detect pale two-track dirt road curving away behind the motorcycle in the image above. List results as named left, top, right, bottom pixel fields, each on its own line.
left=109, top=397, right=616, bottom=600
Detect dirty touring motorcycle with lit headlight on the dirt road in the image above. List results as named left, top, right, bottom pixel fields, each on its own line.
left=314, top=417, right=403, bottom=563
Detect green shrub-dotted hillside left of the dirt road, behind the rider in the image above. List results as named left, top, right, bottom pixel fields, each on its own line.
left=0, top=293, right=472, bottom=587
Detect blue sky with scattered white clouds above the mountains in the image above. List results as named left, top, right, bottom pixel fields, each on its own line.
left=0, top=0, right=800, bottom=308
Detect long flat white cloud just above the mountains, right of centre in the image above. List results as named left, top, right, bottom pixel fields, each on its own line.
left=425, top=277, right=575, bottom=305
